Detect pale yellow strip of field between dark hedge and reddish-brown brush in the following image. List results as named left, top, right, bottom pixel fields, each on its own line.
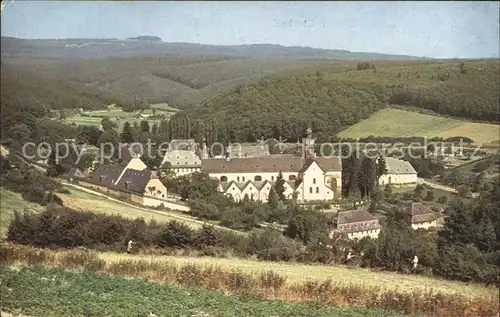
left=99, top=249, right=498, bottom=297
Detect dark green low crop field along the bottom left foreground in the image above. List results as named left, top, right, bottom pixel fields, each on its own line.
left=0, top=266, right=410, bottom=317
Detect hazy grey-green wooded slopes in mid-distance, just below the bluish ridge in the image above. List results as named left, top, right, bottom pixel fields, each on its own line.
left=2, top=55, right=422, bottom=109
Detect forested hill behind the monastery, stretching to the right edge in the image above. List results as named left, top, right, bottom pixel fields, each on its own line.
left=187, top=61, right=500, bottom=142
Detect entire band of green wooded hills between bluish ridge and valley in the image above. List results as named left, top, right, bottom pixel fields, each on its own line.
left=1, top=55, right=500, bottom=147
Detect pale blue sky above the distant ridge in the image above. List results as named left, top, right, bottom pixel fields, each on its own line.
left=1, top=0, right=500, bottom=58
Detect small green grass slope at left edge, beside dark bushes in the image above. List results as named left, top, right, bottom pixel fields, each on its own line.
left=0, top=187, right=44, bottom=239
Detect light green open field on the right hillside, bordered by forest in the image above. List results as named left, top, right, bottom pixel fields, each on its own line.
left=338, top=108, right=500, bottom=143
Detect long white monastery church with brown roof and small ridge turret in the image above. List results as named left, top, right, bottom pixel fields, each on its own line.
left=201, top=129, right=342, bottom=202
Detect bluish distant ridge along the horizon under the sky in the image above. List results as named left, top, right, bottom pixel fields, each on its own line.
left=1, top=36, right=429, bottom=61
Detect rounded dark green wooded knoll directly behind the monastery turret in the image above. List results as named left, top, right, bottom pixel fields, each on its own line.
left=187, top=76, right=384, bottom=142
